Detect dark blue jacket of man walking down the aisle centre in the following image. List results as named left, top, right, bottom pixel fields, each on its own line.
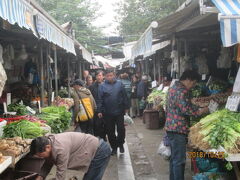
left=97, top=80, right=129, bottom=116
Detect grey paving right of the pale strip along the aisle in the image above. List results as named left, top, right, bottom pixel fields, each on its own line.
left=127, top=118, right=192, bottom=180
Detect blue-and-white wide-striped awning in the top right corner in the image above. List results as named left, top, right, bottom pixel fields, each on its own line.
left=212, top=0, right=240, bottom=47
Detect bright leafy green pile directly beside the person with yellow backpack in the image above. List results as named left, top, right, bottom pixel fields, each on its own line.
left=39, top=106, right=72, bottom=133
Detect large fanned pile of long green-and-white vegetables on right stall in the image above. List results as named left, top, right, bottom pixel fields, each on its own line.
left=189, top=109, right=240, bottom=153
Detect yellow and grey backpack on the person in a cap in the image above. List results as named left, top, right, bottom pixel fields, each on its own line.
left=76, top=91, right=94, bottom=122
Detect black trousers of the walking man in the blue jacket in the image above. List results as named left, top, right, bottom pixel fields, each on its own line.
left=104, top=115, right=125, bottom=149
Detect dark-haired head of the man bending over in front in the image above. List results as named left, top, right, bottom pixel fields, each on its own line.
left=30, top=137, right=52, bottom=158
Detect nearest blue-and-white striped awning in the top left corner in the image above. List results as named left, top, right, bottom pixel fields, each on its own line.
left=0, top=0, right=35, bottom=32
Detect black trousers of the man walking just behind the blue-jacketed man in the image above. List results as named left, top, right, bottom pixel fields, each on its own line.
left=93, top=114, right=106, bottom=141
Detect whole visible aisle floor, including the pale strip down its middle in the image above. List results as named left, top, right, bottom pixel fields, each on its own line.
left=47, top=118, right=192, bottom=180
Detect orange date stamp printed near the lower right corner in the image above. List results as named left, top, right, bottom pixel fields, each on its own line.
left=187, top=151, right=225, bottom=159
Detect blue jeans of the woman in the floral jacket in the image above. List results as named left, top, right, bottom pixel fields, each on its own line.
left=167, top=132, right=187, bottom=180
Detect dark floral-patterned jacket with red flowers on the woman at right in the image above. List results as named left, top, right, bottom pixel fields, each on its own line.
left=165, top=82, right=198, bottom=134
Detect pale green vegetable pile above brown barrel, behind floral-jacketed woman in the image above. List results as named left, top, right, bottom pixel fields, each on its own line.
left=147, top=89, right=167, bottom=109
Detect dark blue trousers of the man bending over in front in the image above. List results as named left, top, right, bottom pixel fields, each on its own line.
left=83, top=139, right=111, bottom=180
